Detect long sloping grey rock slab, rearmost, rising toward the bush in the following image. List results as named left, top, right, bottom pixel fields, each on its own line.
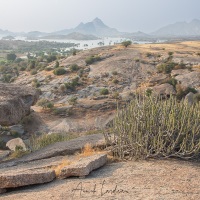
left=0, top=134, right=105, bottom=169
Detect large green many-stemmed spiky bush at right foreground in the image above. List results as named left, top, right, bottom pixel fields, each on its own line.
left=104, top=96, right=200, bottom=159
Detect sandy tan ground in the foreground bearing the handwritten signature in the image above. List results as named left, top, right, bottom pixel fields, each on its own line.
left=0, top=160, right=200, bottom=200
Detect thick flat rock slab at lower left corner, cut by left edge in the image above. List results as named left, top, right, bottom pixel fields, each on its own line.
left=0, top=169, right=56, bottom=188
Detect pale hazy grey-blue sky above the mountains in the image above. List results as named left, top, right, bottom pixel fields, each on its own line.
left=0, top=0, right=200, bottom=33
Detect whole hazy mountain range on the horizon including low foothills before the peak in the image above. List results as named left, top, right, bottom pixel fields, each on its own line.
left=0, top=18, right=200, bottom=41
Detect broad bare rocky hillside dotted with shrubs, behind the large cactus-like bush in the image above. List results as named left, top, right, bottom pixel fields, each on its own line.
left=9, top=41, right=200, bottom=136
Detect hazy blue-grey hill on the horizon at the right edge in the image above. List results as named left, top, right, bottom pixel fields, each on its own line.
left=152, top=19, right=200, bottom=36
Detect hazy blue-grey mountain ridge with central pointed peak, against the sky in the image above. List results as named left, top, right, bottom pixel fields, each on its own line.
left=0, top=17, right=200, bottom=38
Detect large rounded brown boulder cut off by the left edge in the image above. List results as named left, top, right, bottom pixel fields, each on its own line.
left=0, top=83, right=39, bottom=126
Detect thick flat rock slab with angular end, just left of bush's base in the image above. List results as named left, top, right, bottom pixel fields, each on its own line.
left=60, top=154, right=107, bottom=178
